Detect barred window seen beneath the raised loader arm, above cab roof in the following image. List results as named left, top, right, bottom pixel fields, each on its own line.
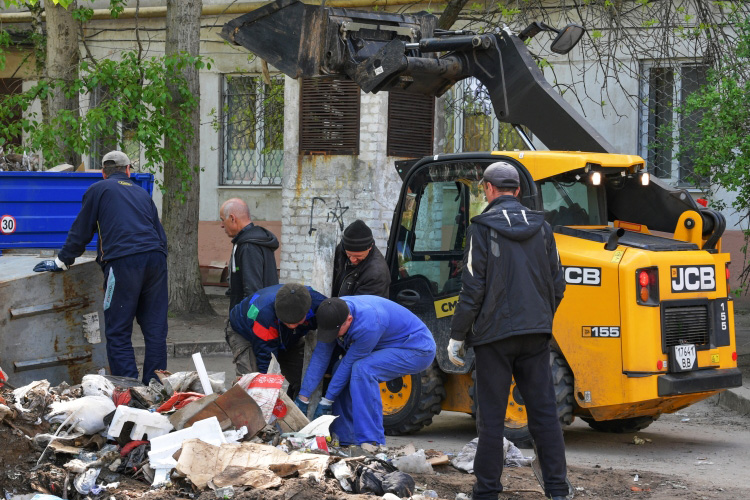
left=438, top=78, right=526, bottom=153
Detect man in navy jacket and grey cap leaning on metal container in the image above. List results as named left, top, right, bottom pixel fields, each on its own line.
left=34, top=151, right=168, bottom=384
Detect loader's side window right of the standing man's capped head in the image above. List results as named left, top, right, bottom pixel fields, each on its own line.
left=540, top=179, right=607, bottom=227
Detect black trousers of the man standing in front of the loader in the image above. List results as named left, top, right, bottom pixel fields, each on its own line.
left=472, top=333, right=568, bottom=500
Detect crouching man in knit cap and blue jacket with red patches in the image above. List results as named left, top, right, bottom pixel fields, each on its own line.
left=229, top=283, right=326, bottom=399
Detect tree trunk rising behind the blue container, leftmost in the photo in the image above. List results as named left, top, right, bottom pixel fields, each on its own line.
left=44, top=2, right=81, bottom=167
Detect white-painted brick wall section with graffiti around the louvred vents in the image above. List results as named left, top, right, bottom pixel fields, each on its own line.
left=280, top=84, right=401, bottom=292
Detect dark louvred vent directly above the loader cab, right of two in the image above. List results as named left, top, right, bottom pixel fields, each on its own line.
left=387, top=90, right=435, bottom=158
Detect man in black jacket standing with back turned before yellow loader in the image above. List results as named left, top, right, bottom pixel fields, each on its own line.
left=448, top=162, right=568, bottom=500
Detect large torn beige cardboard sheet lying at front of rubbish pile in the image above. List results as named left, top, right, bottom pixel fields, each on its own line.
left=177, top=439, right=329, bottom=488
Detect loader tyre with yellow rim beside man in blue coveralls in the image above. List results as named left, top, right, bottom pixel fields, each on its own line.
left=380, top=363, right=445, bottom=436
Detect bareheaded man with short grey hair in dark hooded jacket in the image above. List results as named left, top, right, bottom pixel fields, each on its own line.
left=219, top=198, right=279, bottom=375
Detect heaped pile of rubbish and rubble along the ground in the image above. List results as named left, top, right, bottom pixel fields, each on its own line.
left=0, top=362, right=531, bottom=500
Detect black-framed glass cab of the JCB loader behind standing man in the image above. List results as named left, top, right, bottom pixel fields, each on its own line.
left=386, top=154, right=541, bottom=373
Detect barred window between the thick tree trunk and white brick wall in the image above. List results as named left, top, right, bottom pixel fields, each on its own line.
left=221, top=75, right=284, bottom=186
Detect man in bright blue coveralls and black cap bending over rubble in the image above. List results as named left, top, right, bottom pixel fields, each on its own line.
left=296, top=295, right=435, bottom=445
